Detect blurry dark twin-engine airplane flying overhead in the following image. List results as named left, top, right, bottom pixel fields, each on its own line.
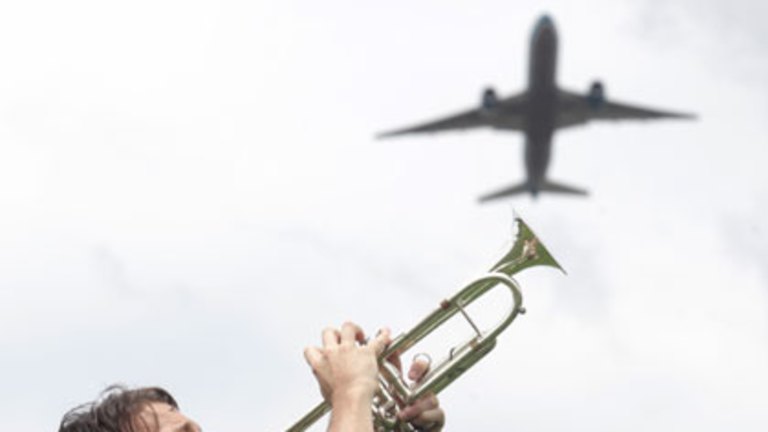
left=377, top=15, right=696, bottom=202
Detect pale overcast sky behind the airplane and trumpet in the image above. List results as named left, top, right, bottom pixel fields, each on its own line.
left=0, top=0, right=768, bottom=432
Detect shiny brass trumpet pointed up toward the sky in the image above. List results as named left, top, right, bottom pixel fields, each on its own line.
left=287, top=217, right=565, bottom=432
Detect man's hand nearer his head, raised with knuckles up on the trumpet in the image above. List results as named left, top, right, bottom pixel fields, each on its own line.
left=304, top=322, right=389, bottom=406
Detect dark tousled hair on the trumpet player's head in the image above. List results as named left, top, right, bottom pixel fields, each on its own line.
left=59, top=386, right=179, bottom=432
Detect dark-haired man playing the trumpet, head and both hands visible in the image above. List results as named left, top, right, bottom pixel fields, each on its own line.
left=59, top=323, right=445, bottom=432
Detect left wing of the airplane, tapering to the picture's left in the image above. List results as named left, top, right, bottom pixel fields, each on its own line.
left=376, top=94, right=525, bottom=138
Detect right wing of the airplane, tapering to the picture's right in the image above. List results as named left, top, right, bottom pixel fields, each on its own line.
left=557, top=90, right=696, bottom=128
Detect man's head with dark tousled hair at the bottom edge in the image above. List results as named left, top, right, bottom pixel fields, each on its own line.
left=59, top=387, right=200, bottom=432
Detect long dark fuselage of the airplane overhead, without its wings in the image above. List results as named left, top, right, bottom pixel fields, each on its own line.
left=525, top=16, right=557, bottom=195
